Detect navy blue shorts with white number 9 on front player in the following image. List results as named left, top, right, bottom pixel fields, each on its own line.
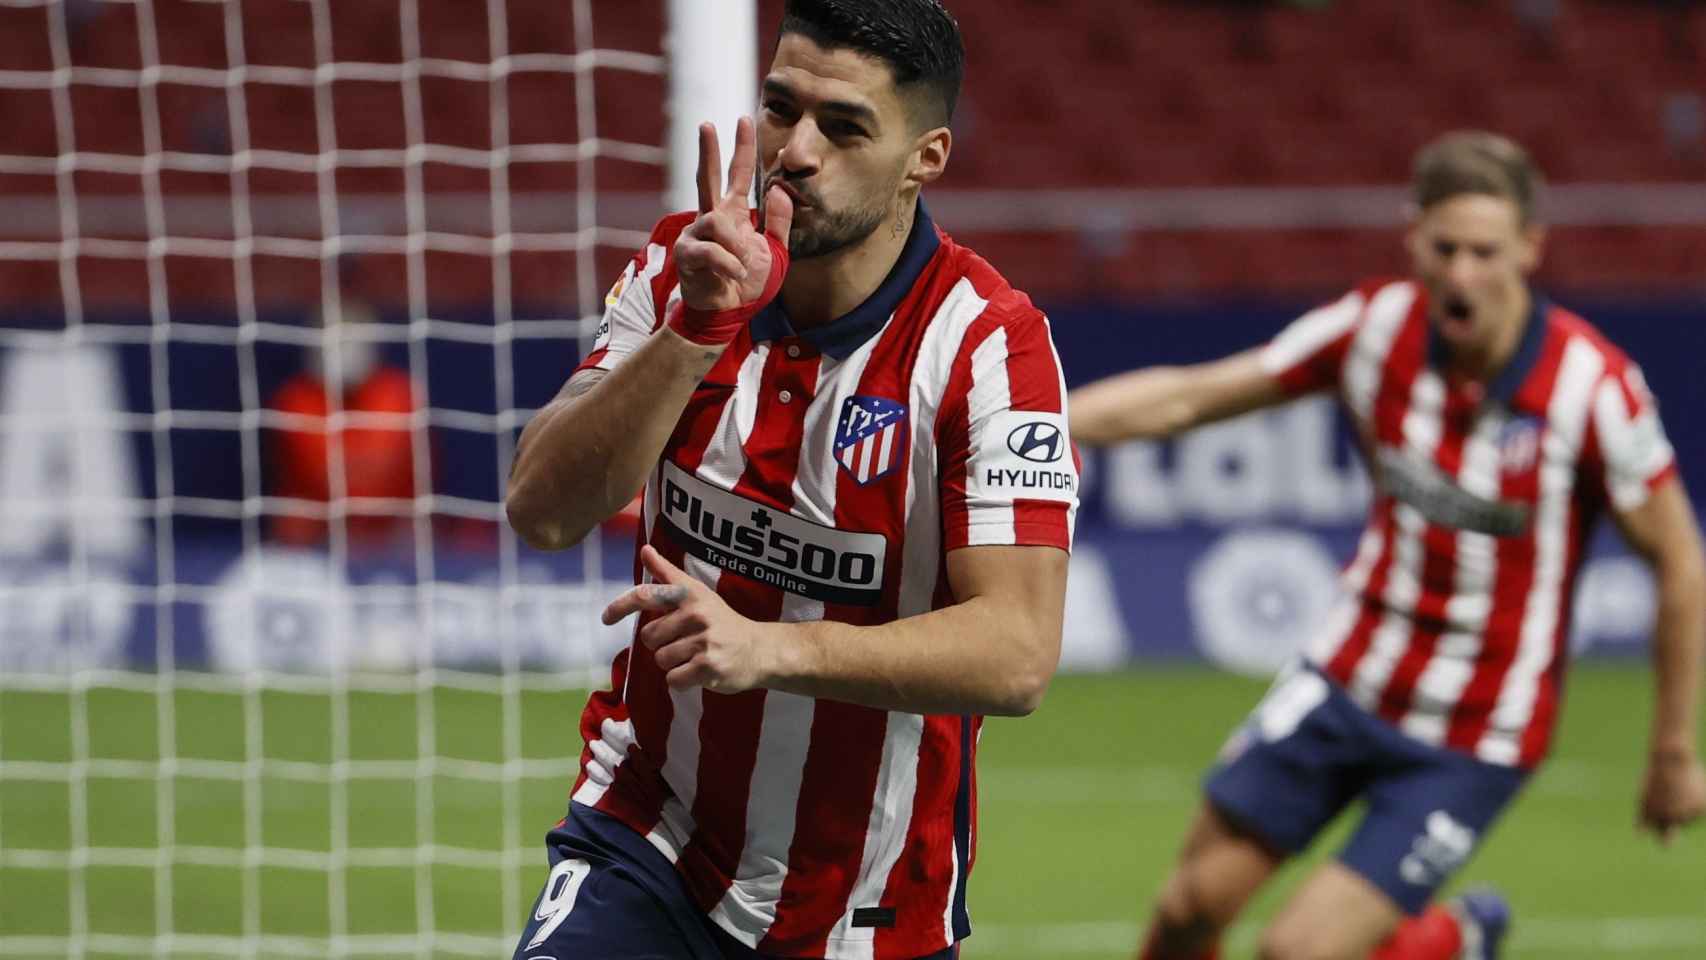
left=515, top=803, right=957, bottom=960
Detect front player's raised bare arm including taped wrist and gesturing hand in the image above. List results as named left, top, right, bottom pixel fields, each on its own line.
left=505, top=118, right=793, bottom=549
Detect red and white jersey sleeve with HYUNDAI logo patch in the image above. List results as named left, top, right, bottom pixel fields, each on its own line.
left=940, top=305, right=1078, bottom=551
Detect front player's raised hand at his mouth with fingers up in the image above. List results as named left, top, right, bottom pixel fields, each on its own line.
left=676, top=116, right=793, bottom=312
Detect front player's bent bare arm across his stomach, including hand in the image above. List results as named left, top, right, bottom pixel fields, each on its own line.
left=604, top=546, right=1066, bottom=716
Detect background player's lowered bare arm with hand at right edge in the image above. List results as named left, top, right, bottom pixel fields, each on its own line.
left=1614, top=474, right=1706, bottom=841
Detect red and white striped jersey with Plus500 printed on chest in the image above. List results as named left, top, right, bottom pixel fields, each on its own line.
left=573, top=205, right=1078, bottom=960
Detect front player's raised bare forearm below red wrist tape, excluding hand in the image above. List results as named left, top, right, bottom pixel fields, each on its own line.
left=505, top=327, right=722, bottom=549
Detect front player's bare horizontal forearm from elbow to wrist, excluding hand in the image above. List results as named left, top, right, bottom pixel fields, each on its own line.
left=759, top=597, right=1061, bottom=716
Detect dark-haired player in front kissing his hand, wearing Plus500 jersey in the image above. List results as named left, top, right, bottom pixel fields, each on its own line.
left=507, top=0, right=1078, bottom=960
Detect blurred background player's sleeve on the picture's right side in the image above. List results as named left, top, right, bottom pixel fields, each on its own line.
left=1593, top=363, right=1677, bottom=510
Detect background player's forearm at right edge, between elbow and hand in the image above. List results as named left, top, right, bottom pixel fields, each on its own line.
left=1651, top=559, right=1706, bottom=755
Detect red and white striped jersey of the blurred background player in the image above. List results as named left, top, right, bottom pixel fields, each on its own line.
left=1262, top=281, right=1675, bottom=767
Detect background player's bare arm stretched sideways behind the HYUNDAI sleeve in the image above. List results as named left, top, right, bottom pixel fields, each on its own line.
left=1068, top=350, right=1290, bottom=447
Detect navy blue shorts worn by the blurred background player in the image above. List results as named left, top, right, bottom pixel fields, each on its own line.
left=1204, top=667, right=1529, bottom=914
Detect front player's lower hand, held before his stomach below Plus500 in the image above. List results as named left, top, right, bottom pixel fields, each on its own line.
left=604, top=544, right=764, bottom=694
